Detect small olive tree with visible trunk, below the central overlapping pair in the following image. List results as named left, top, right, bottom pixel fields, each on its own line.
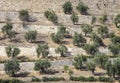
left=55, top=45, right=68, bottom=57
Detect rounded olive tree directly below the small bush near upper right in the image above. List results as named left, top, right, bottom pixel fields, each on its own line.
left=98, top=26, right=109, bottom=38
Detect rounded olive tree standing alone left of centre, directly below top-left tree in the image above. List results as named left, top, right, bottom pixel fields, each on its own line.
left=24, top=31, right=37, bottom=42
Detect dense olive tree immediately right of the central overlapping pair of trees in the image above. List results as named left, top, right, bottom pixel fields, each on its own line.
left=73, top=33, right=86, bottom=46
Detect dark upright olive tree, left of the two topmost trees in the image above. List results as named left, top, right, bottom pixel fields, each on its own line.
left=62, top=1, right=73, bottom=14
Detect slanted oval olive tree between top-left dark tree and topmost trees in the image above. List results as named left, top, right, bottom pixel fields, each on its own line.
left=44, top=10, right=58, bottom=23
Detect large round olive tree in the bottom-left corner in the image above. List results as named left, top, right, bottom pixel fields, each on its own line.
left=4, top=59, right=20, bottom=76
